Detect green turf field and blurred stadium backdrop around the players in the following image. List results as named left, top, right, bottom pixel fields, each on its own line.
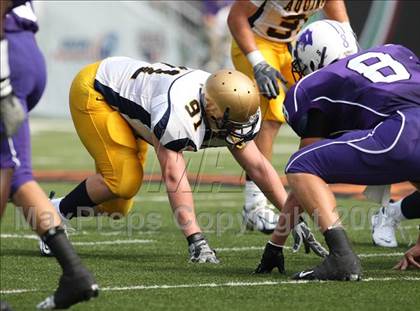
left=0, top=0, right=420, bottom=311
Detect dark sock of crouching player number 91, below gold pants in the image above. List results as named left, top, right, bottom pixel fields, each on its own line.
left=60, top=180, right=97, bottom=219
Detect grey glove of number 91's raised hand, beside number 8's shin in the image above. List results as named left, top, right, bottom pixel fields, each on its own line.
left=292, top=217, right=328, bottom=257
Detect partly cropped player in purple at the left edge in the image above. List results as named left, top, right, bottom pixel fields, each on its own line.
left=0, top=1, right=98, bottom=309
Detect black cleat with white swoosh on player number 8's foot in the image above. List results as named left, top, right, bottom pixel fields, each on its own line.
left=292, top=253, right=362, bottom=281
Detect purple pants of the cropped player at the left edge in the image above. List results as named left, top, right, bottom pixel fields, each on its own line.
left=0, top=31, right=46, bottom=194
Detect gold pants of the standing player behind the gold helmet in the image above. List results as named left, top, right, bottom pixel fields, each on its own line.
left=231, top=36, right=294, bottom=123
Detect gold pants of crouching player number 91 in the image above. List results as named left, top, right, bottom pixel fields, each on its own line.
left=70, top=63, right=147, bottom=215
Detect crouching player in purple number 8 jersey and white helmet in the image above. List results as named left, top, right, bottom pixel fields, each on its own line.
left=257, top=21, right=420, bottom=280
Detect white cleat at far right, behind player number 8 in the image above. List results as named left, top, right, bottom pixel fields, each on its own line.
left=371, top=207, right=398, bottom=247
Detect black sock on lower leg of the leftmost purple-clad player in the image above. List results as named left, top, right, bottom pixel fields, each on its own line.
left=41, top=227, right=81, bottom=274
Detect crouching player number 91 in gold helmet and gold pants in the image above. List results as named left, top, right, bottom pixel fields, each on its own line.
left=41, top=57, right=328, bottom=263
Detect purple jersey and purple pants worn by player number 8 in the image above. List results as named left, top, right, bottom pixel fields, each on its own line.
left=284, top=45, right=420, bottom=185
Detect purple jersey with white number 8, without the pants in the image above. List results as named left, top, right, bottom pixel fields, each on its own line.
left=284, top=45, right=420, bottom=135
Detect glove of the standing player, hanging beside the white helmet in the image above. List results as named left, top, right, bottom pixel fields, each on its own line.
left=253, top=61, right=287, bottom=99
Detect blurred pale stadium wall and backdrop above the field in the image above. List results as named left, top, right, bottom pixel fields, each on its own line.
left=34, top=0, right=420, bottom=118
